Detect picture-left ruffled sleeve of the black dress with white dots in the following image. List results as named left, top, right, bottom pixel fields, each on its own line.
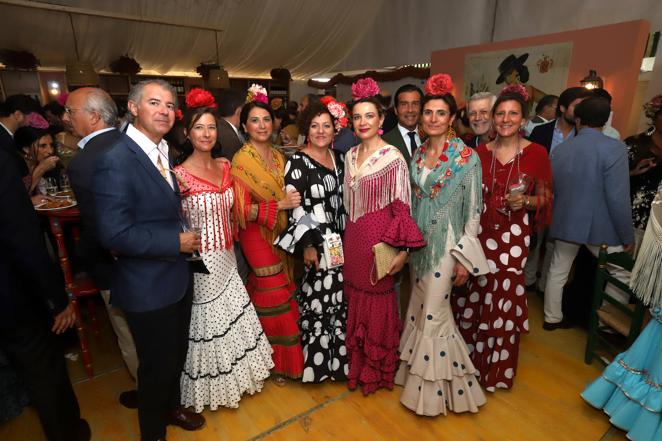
left=274, top=154, right=325, bottom=253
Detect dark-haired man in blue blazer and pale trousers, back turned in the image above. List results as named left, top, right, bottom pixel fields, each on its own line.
left=543, top=97, right=634, bottom=330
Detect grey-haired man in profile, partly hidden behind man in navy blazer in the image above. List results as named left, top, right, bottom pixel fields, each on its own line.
left=63, top=87, right=138, bottom=409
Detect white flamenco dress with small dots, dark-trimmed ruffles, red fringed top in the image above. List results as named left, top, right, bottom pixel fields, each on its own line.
left=176, top=163, right=274, bottom=412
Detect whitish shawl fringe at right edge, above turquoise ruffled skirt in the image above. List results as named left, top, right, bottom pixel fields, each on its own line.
left=630, top=200, right=662, bottom=307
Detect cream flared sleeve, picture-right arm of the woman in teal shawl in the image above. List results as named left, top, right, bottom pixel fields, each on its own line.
left=450, top=162, right=489, bottom=276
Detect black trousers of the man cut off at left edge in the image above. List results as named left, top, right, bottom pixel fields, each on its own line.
left=0, top=311, right=84, bottom=441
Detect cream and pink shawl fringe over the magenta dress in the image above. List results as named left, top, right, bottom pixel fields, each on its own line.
left=344, top=158, right=411, bottom=222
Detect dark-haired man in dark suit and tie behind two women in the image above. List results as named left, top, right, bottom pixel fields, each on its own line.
left=383, top=84, right=423, bottom=164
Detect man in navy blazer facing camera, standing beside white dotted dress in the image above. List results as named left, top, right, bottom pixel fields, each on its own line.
left=92, top=80, right=204, bottom=441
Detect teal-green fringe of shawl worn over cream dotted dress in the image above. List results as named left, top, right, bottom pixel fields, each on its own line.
left=411, top=161, right=483, bottom=274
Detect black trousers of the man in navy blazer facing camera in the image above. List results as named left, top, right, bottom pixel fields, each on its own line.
left=124, top=286, right=193, bottom=441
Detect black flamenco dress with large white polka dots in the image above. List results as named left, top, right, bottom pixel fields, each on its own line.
left=276, top=152, right=348, bottom=383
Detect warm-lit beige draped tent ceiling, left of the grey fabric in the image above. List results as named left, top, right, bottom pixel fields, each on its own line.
left=0, top=0, right=383, bottom=78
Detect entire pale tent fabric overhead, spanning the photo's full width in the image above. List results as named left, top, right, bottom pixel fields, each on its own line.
left=0, top=0, right=662, bottom=79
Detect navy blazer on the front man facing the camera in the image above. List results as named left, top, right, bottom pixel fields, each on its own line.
left=92, top=134, right=189, bottom=312
